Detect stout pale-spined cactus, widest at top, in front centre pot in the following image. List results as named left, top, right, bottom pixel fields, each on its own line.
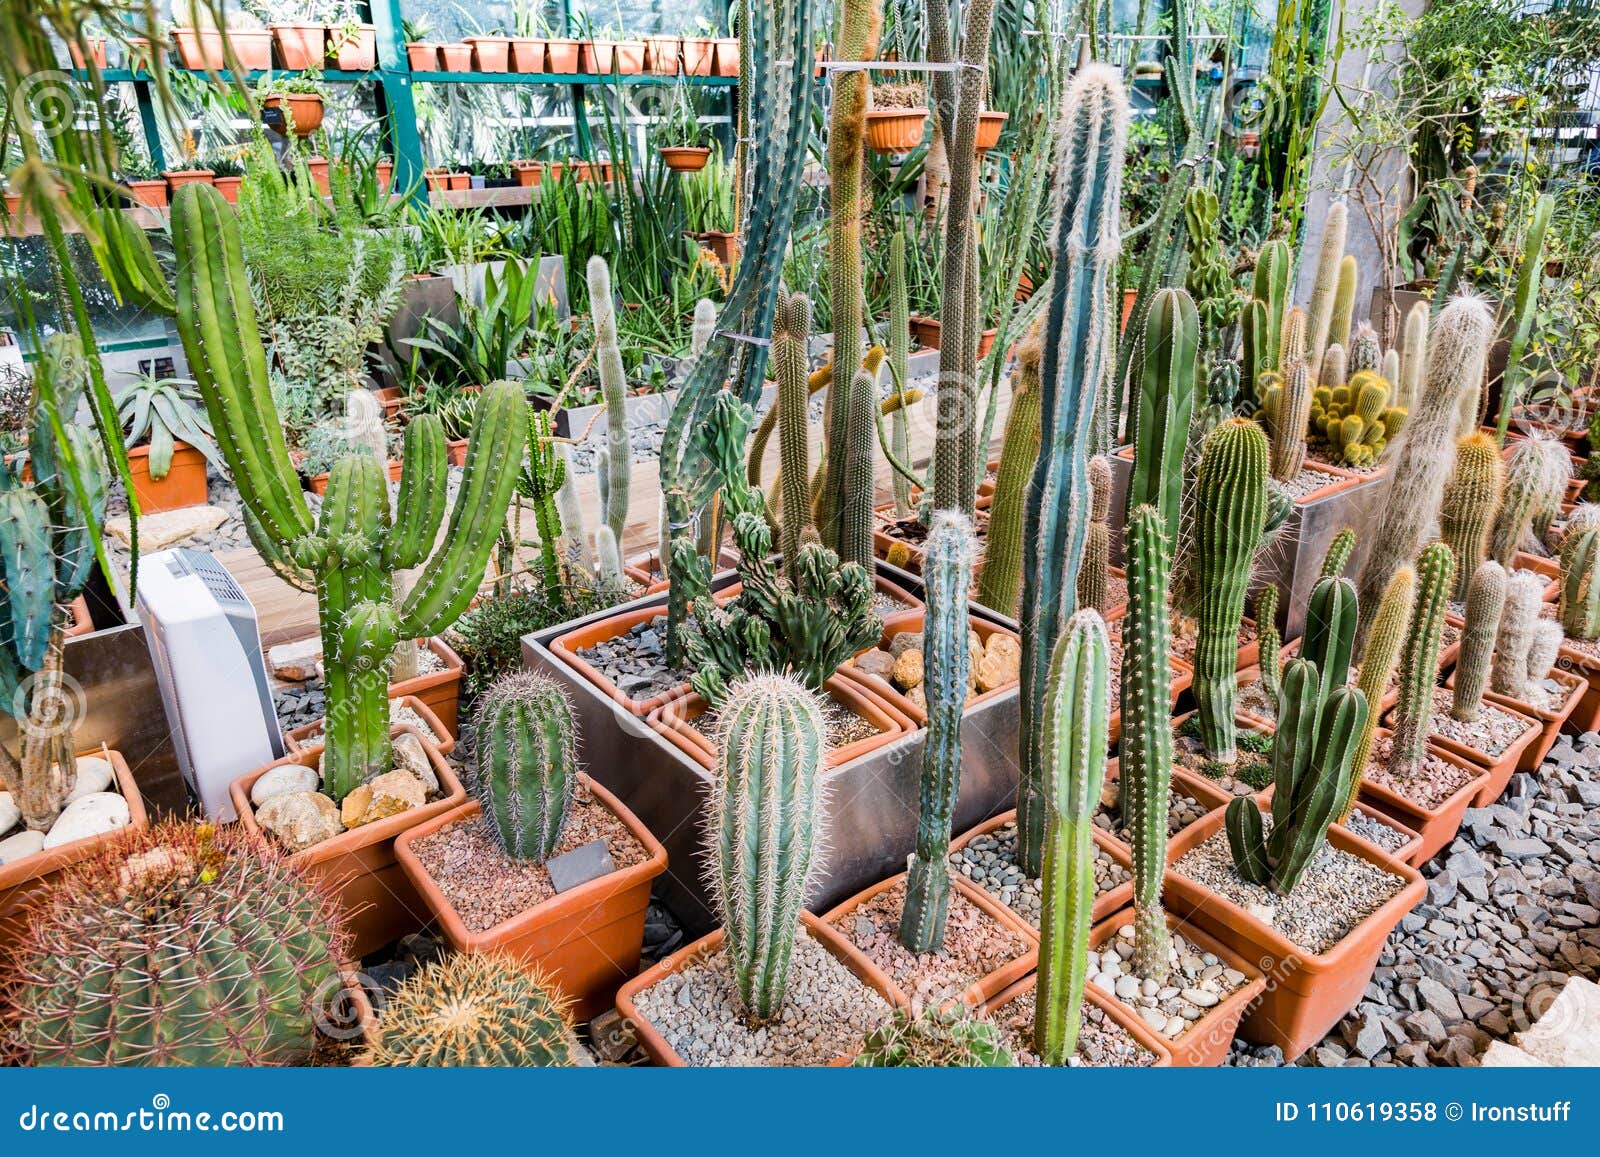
left=710, top=675, right=824, bottom=1021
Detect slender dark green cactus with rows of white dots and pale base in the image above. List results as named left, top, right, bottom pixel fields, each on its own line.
left=1122, top=506, right=1184, bottom=983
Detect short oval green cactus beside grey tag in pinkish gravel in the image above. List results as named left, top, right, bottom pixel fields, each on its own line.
left=474, top=671, right=578, bottom=864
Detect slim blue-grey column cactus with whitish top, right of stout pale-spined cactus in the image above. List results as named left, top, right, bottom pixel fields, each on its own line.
left=899, top=510, right=974, bottom=952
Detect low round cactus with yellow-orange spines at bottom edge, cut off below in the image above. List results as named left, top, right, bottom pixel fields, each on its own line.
left=366, top=952, right=576, bottom=1069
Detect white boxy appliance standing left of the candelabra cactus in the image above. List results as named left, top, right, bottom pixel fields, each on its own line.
left=138, top=550, right=283, bottom=821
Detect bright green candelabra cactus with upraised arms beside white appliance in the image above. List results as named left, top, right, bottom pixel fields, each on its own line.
left=173, top=184, right=528, bottom=800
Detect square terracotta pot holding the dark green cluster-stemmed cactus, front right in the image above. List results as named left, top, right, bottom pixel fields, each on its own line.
left=1163, top=811, right=1427, bottom=1059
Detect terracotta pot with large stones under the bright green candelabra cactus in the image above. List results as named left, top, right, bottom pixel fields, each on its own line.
left=227, top=727, right=467, bottom=957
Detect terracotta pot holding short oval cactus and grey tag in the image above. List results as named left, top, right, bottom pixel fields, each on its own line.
left=395, top=776, right=667, bottom=1021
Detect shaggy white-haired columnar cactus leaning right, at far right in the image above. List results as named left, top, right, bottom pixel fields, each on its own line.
left=1358, top=298, right=1494, bottom=646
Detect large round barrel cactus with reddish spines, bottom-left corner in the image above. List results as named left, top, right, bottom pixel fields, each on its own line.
left=0, top=823, right=344, bottom=1066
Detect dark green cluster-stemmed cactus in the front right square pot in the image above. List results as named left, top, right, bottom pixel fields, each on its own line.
left=1226, top=658, right=1368, bottom=896
